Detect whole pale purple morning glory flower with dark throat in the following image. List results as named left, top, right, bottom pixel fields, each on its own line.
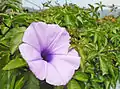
left=19, top=22, right=80, bottom=86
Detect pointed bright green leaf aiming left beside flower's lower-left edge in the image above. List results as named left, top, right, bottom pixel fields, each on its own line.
left=3, top=58, right=26, bottom=70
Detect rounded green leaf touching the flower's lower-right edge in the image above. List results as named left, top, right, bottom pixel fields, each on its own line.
left=73, top=71, right=89, bottom=82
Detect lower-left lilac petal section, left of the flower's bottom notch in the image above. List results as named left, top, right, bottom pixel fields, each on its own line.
left=28, top=60, right=47, bottom=80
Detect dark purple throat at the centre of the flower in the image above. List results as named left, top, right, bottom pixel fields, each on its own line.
left=41, top=49, right=52, bottom=62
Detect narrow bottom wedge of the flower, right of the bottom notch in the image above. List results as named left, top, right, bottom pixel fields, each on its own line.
left=46, top=63, right=65, bottom=86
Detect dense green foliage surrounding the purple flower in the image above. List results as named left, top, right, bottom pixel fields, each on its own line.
left=0, top=0, right=120, bottom=89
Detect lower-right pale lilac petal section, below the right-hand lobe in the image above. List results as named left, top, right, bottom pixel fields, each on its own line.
left=50, top=57, right=75, bottom=85
